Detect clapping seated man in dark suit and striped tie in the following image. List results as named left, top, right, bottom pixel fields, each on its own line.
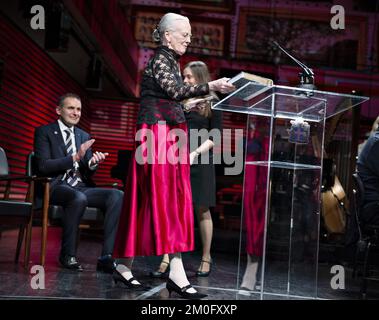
left=34, top=93, right=123, bottom=273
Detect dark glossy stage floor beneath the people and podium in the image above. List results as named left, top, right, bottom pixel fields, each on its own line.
left=0, top=228, right=379, bottom=300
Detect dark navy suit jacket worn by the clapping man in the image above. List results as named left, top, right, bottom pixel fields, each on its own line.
left=34, top=121, right=95, bottom=190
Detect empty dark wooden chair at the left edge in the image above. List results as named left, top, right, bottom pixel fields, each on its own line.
left=0, top=147, right=34, bottom=268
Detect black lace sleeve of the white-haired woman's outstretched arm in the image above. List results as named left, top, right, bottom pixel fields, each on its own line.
left=152, top=54, right=209, bottom=101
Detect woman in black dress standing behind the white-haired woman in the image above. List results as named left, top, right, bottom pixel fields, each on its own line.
left=151, top=61, right=222, bottom=278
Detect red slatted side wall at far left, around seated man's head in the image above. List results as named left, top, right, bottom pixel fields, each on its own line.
left=0, top=17, right=89, bottom=198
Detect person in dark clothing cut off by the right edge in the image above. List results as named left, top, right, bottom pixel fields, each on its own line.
left=357, top=128, right=379, bottom=225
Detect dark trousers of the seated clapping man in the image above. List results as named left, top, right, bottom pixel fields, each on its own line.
left=50, top=181, right=124, bottom=256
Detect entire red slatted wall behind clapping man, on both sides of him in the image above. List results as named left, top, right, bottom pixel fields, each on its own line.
left=0, top=18, right=138, bottom=199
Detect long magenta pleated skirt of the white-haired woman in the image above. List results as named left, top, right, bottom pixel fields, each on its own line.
left=113, top=123, right=194, bottom=258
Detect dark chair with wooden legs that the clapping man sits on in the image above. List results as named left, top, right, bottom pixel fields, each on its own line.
left=26, top=152, right=113, bottom=266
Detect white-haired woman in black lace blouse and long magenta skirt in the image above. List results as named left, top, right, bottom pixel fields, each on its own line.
left=114, top=13, right=234, bottom=299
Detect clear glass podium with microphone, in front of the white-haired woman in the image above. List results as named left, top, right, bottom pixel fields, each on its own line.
left=212, top=82, right=368, bottom=299
